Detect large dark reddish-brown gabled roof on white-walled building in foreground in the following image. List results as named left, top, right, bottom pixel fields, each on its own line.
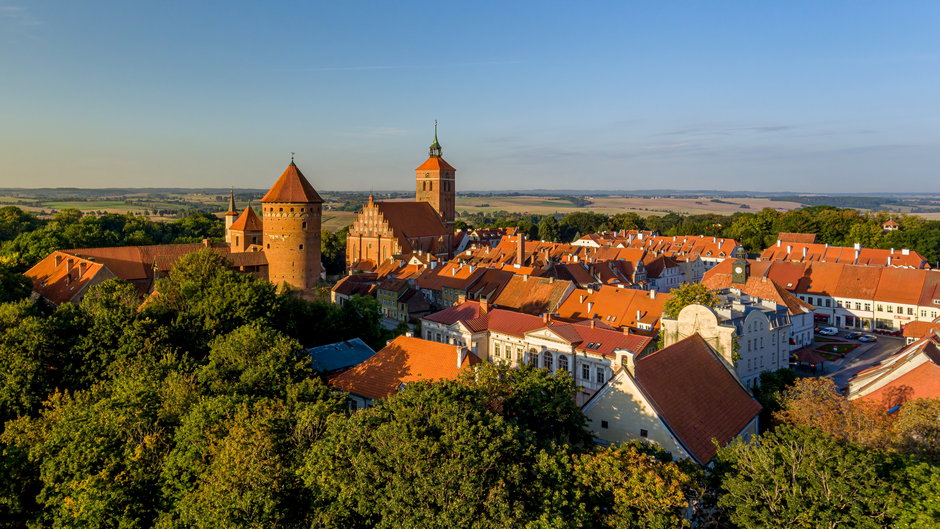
left=635, top=334, right=761, bottom=464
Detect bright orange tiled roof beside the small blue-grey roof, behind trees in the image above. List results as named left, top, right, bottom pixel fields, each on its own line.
left=329, top=336, right=482, bottom=399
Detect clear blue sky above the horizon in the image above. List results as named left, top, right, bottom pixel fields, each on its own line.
left=0, top=0, right=940, bottom=192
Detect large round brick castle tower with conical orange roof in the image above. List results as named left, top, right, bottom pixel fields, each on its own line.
left=261, top=158, right=323, bottom=289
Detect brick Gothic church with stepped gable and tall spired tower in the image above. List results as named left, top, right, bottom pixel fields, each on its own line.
left=346, top=124, right=457, bottom=270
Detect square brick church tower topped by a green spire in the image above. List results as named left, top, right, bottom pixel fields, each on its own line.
left=415, top=121, right=457, bottom=255
